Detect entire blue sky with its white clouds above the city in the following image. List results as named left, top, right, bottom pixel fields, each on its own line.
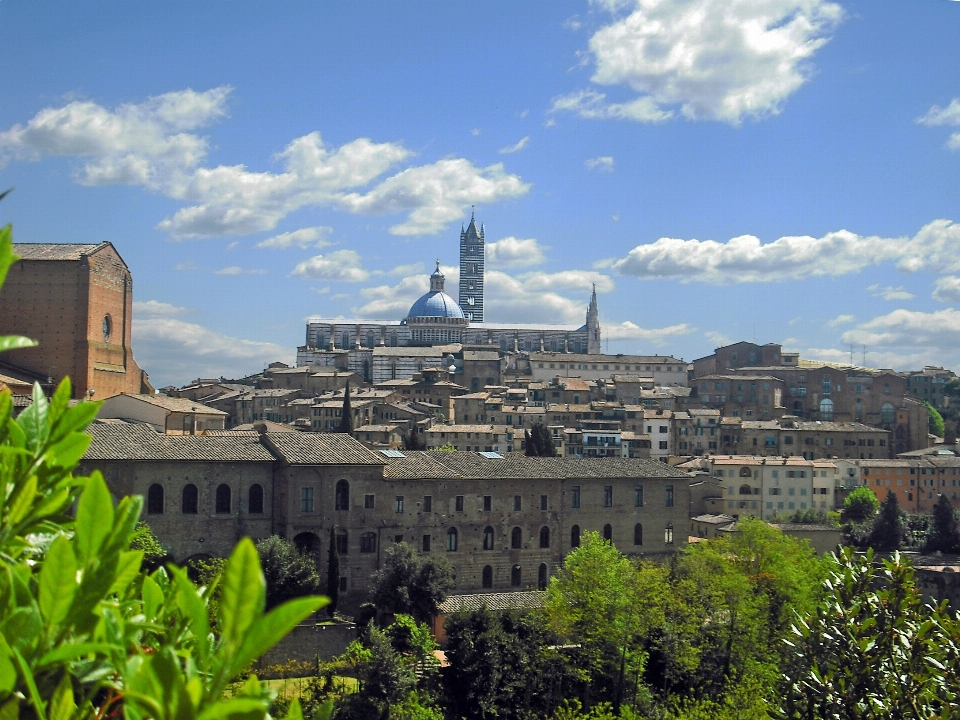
left=0, top=0, right=960, bottom=385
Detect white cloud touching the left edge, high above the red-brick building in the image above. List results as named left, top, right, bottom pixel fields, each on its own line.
left=0, top=86, right=231, bottom=190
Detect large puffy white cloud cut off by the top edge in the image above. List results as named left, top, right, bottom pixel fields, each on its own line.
left=552, top=0, right=843, bottom=125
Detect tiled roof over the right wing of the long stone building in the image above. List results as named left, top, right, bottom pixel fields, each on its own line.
left=384, top=451, right=687, bottom=480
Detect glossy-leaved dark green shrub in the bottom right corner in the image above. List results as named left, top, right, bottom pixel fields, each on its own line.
left=777, top=549, right=960, bottom=720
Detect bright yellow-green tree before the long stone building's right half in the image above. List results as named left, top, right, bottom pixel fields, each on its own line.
left=544, top=532, right=669, bottom=711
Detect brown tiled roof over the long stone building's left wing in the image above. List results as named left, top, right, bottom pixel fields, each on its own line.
left=83, top=421, right=274, bottom=462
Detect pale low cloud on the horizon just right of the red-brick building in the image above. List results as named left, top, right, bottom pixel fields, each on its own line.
left=133, top=316, right=295, bottom=387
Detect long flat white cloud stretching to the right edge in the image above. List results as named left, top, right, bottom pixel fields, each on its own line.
left=612, top=220, right=960, bottom=285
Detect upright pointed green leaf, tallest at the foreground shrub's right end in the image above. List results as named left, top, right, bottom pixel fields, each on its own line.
left=220, top=538, right=266, bottom=651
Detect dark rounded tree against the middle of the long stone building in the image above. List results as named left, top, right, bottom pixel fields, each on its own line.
left=372, top=542, right=454, bottom=623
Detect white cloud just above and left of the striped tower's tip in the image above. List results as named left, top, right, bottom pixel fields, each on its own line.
left=337, top=159, right=530, bottom=235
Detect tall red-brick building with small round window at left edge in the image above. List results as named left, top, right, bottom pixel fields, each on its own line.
left=0, top=242, right=153, bottom=398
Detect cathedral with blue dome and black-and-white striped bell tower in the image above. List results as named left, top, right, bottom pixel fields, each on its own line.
left=297, top=217, right=601, bottom=372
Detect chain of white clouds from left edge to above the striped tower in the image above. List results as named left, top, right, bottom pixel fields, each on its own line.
left=0, top=87, right=530, bottom=238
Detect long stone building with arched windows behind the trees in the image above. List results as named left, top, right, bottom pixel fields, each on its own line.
left=82, top=421, right=689, bottom=609
